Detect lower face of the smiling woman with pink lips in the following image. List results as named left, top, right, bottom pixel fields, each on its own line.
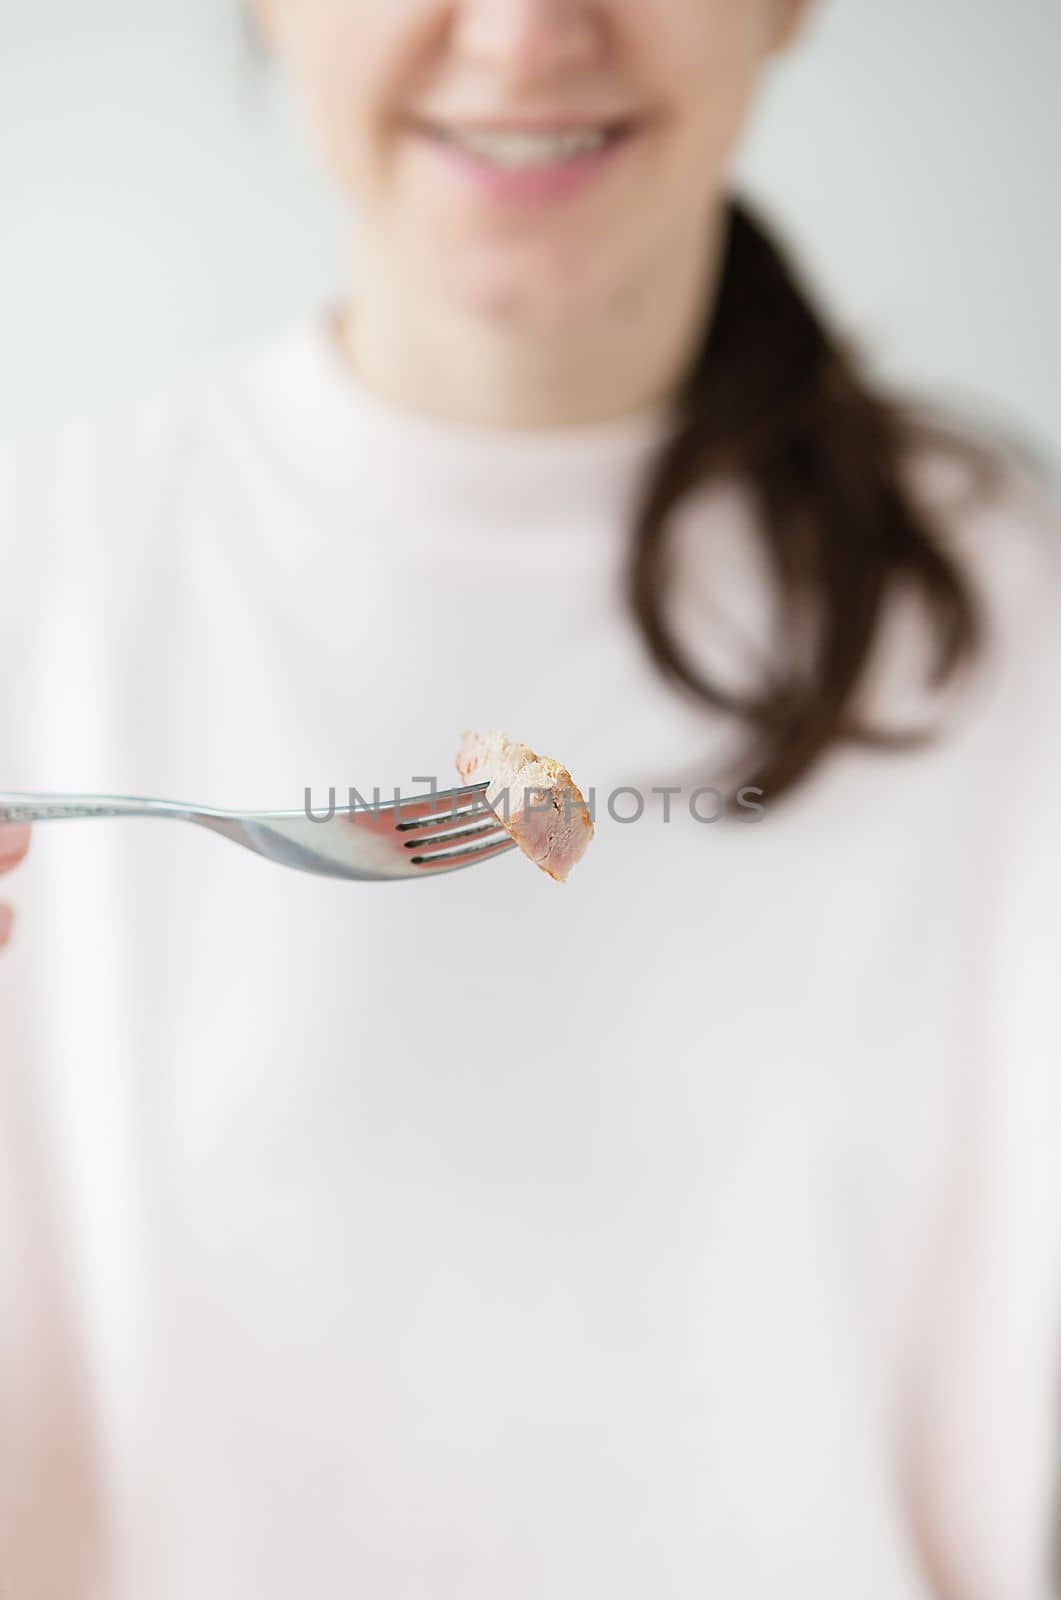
left=258, top=0, right=803, bottom=326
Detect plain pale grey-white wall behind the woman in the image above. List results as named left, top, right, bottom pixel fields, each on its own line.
left=0, top=0, right=1061, bottom=456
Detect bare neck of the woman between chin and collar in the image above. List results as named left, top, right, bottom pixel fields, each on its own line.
left=341, top=219, right=723, bottom=427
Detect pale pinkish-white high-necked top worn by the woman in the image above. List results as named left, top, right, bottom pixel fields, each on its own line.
left=0, top=310, right=1061, bottom=1600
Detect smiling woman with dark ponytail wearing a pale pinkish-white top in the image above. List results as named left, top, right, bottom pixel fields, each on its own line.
left=0, top=0, right=1061, bottom=1600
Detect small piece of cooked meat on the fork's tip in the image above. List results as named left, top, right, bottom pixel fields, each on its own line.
left=456, top=733, right=594, bottom=883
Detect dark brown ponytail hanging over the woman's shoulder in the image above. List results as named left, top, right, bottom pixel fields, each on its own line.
left=629, top=200, right=986, bottom=798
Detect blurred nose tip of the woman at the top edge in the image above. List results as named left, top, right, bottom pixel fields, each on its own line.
left=456, top=0, right=605, bottom=82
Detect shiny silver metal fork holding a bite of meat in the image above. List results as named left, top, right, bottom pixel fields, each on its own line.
left=0, top=782, right=515, bottom=883
